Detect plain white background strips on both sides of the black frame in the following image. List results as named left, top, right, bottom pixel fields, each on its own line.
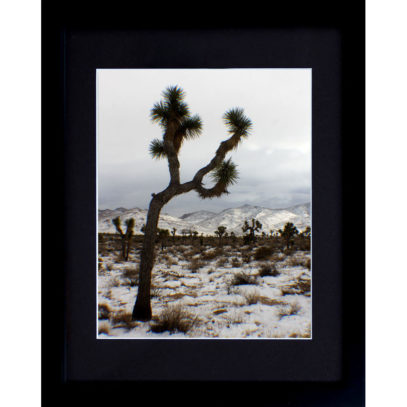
left=0, top=0, right=407, bottom=407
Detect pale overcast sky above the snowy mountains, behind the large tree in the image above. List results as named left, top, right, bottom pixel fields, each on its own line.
left=97, top=69, right=311, bottom=215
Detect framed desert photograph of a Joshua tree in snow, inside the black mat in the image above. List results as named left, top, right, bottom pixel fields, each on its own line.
left=95, top=68, right=312, bottom=340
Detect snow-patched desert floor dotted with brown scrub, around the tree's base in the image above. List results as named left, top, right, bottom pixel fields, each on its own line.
left=97, top=244, right=311, bottom=339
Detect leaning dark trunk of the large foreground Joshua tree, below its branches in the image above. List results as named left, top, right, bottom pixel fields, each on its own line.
left=133, top=195, right=164, bottom=321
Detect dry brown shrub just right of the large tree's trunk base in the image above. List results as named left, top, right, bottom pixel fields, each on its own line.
left=151, top=304, right=197, bottom=333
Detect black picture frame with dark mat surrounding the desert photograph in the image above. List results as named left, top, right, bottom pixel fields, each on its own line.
left=42, top=1, right=365, bottom=406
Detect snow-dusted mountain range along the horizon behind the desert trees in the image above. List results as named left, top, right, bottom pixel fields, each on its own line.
left=98, top=203, right=311, bottom=235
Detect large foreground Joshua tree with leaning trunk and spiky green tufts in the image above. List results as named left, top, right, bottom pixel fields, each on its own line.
left=133, top=86, right=252, bottom=321
